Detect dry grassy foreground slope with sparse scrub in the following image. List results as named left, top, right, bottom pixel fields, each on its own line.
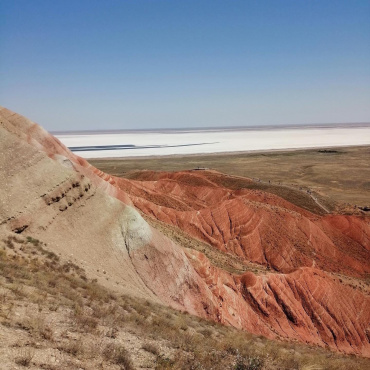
left=0, top=233, right=369, bottom=370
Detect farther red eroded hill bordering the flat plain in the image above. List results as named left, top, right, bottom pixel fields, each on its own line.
left=116, top=171, right=370, bottom=276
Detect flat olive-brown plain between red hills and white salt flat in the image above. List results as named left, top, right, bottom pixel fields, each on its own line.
left=89, top=146, right=370, bottom=212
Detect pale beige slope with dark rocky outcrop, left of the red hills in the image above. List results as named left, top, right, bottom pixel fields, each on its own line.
left=0, top=108, right=217, bottom=316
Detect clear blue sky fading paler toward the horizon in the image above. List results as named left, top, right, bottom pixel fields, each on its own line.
left=0, top=0, right=370, bottom=130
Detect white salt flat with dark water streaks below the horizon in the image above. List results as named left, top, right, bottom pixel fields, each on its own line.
left=56, top=126, right=370, bottom=158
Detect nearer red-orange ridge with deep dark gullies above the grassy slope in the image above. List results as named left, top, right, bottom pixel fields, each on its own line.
left=189, top=251, right=370, bottom=354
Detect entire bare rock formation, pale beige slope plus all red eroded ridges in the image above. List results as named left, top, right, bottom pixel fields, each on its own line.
left=0, top=108, right=370, bottom=356
